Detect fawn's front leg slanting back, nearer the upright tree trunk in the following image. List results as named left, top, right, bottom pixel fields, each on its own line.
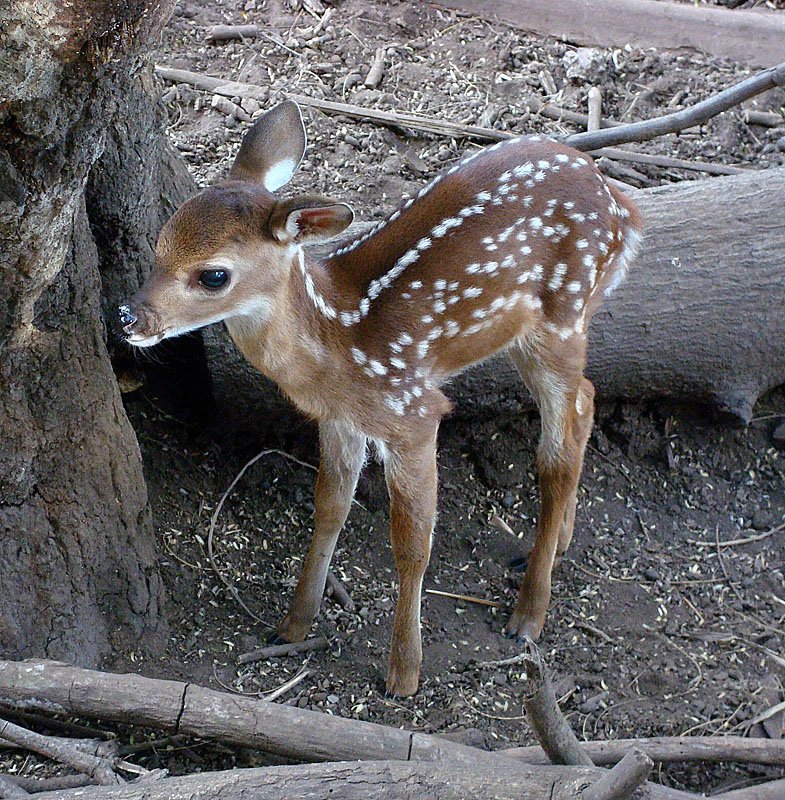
left=278, top=422, right=365, bottom=642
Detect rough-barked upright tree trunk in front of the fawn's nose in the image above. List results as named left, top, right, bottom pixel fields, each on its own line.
left=0, top=0, right=182, bottom=664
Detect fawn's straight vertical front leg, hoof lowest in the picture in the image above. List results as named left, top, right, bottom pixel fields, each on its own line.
left=378, top=425, right=438, bottom=697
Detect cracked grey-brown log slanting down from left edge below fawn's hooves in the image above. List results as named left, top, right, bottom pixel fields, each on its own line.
left=0, top=659, right=508, bottom=764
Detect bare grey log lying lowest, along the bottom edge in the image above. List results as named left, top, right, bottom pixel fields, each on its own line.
left=26, top=760, right=698, bottom=800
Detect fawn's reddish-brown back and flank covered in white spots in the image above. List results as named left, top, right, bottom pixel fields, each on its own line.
left=302, top=137, right=640, bottom=424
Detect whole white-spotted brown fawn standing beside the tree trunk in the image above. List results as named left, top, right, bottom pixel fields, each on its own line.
left=120, top=101, right=641, bottom=696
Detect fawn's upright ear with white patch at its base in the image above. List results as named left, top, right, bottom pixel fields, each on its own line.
left=229, top=100, right=305, bottom=192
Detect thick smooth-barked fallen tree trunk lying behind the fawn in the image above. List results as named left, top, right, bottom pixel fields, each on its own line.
left=206, top=168, right=785, bottom=440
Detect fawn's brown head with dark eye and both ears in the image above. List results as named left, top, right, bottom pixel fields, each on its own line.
left=119, top=101, right=354, bottom=347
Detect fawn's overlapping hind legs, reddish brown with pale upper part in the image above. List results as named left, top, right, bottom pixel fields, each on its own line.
left=507, top=336, right=594, bottom=639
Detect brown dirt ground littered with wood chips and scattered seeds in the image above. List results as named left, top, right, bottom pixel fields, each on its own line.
left=13, top=0, right=785, bottom=790
